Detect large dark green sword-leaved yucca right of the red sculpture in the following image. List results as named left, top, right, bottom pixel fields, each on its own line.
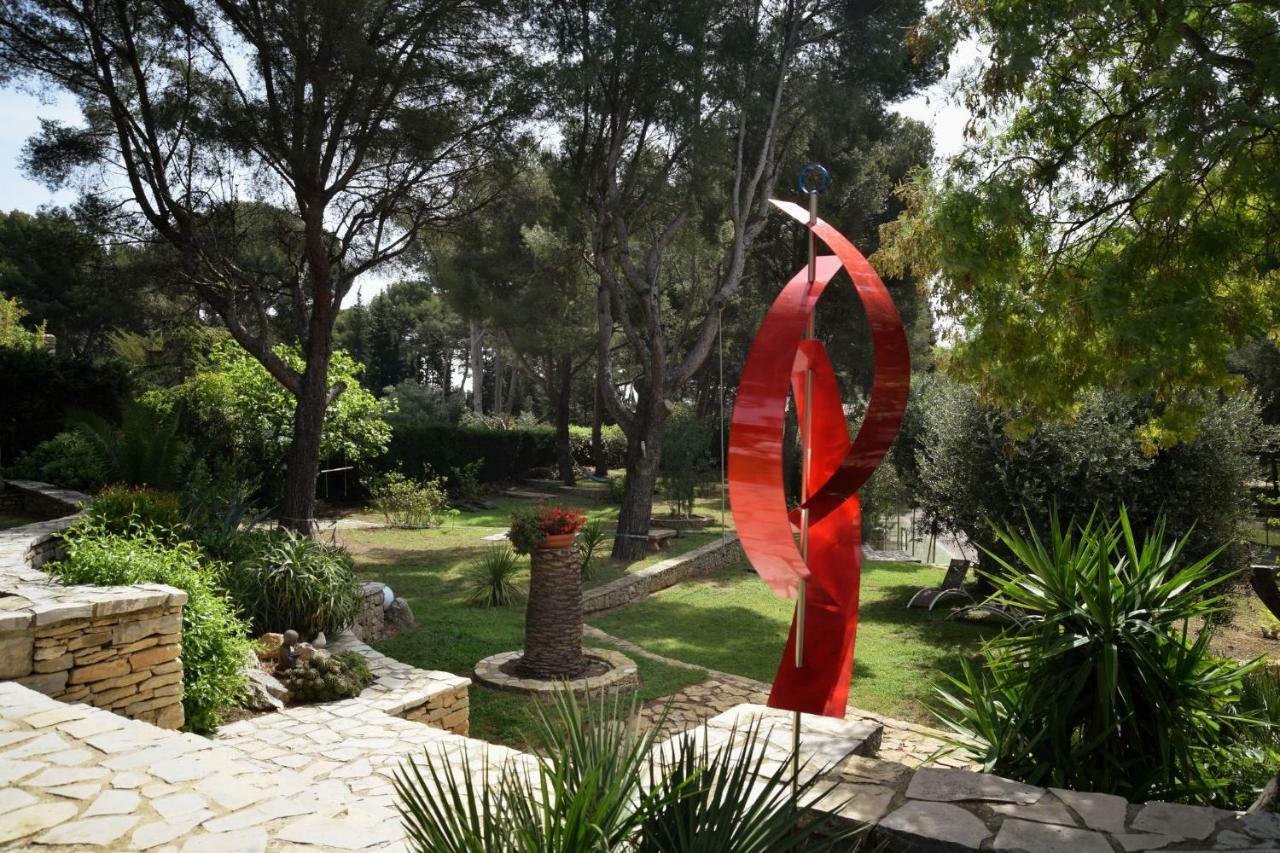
left=940, top=510, right=1257, bottom=802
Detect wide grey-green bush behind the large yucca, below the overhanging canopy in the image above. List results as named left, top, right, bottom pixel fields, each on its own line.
left=899, top=382, right=1258, bottom=570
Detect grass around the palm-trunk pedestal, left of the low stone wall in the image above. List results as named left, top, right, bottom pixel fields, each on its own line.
left=339, top=500, right=707, bottom=744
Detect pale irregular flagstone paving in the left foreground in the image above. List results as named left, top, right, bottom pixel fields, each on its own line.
left=0, top=681, right=532, bottom=853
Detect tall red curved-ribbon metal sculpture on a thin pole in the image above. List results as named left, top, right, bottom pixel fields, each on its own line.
left=728, top=188, right=911, bottom=717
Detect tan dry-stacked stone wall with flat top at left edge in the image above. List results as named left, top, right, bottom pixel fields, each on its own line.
left=0, top=480, right=187, bottom=729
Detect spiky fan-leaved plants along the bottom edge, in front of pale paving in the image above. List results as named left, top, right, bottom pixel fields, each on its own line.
left=394, top=692, right=860, bottom=853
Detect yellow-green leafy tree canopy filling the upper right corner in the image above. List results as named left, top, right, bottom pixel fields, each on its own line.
left=877, top=0, right=1280, bottom=448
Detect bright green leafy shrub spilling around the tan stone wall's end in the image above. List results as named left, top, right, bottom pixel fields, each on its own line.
left=45, top=519, right=250, bottom=731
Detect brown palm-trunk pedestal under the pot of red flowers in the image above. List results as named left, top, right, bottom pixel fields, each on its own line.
left=518, top=545, right=588, bottom=679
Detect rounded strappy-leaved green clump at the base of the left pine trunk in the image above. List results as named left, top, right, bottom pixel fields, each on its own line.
left=224, top=528, right=362, bottom=638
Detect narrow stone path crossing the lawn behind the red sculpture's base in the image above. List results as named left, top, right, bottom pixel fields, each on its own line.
left=582, top=625, right=978, bottom=770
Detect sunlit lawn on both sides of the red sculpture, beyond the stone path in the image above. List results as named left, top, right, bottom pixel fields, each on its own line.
left=591, top=562, right=984, bottom=724
